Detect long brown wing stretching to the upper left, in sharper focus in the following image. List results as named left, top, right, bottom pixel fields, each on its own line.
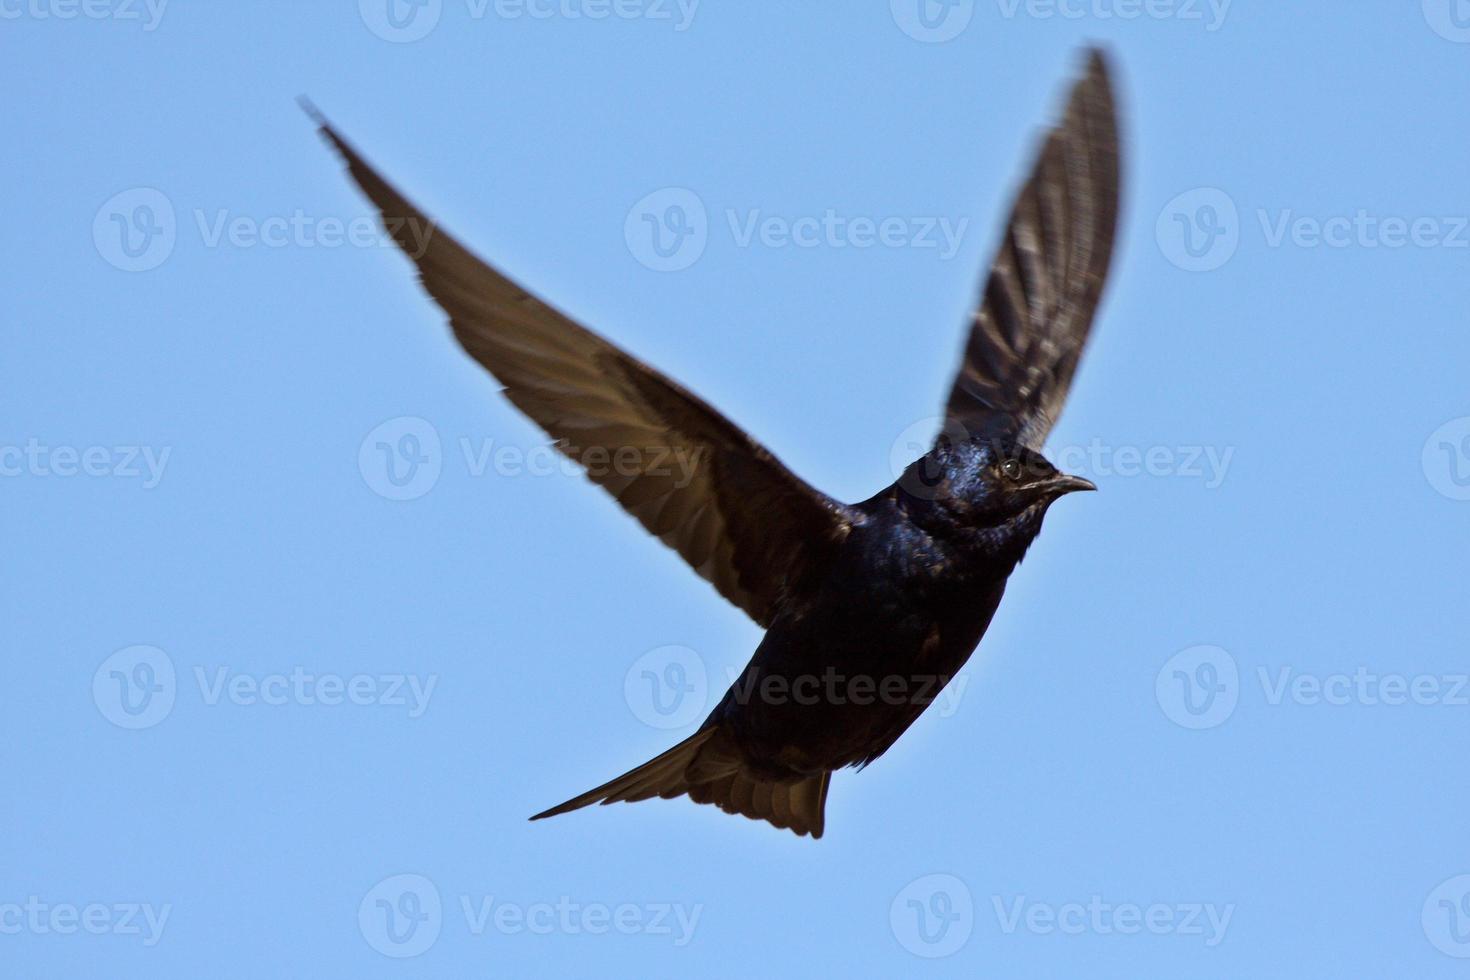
left=316, top=107, right=853, bottom=626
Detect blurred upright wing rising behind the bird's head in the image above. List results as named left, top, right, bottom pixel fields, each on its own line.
left=945, top=50, right=1119, bottom=450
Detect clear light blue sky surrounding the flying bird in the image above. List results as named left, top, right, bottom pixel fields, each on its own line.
left=0, top=0, right=1470, bottom=979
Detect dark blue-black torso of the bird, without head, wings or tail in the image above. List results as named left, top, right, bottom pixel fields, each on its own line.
left=707, top=481, right=1039, bottom=776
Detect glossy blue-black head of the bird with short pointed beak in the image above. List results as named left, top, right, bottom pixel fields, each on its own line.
left=898, top=436, right=1097, bottom=533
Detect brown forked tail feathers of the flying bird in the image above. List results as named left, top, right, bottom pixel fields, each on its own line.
left=532, top=727, right=832, bottom=837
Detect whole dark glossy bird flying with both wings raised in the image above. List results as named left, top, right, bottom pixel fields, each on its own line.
left=307, top=50, right=1119, bottom=837
